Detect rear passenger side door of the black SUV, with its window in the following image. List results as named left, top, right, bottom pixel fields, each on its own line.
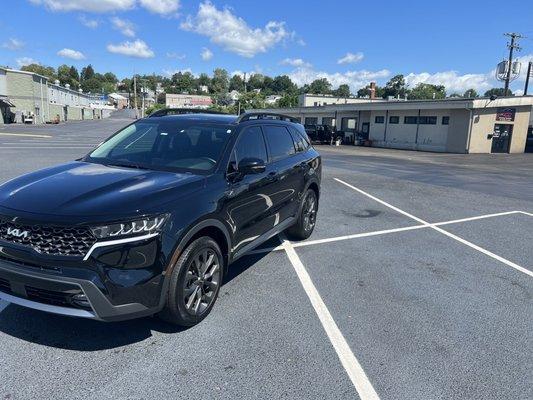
left=263, top=124, right=304, bottom=222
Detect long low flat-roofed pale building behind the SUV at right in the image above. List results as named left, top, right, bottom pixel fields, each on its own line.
left=260, top=96, right=533, bottom=153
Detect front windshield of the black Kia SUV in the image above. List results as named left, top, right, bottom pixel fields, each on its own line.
left=85, top=120, right=232, bottom=171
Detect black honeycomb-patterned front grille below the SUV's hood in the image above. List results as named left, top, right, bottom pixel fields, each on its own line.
left=0, top=219, right=96, bottom=257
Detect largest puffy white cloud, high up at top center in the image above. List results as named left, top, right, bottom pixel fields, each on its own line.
left=181, top=1, right=291, bottom=58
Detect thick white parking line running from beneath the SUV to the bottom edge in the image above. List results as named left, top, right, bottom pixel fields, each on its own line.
left=280, top=237, right=379, bottom=400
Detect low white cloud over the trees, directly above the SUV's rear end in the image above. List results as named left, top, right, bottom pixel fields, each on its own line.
left=289, top=68, right=391, bottom=92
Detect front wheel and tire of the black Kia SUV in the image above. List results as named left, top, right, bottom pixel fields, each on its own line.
left=159, top=236, right=224, bottom=326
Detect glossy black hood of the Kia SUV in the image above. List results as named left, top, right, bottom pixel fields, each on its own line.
left=0, top=162, right=204, bottom=217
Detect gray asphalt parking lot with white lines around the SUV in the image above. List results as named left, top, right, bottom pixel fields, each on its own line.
left=0, top=116, right=533, bottom=399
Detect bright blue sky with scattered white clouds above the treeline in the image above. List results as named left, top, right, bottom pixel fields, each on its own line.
left=0, top=0, right=533, bottom=93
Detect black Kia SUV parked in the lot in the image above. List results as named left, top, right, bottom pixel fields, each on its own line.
left=0, top=112, right=322, bottom=326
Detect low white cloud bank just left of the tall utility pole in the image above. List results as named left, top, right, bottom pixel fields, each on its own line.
left=405, top=71, right=498, bottom=94
